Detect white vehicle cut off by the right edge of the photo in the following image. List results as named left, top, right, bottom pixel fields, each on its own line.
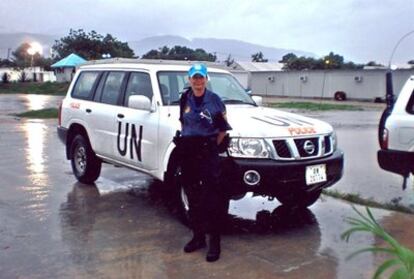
left=378, top=76, right=414, bottom=188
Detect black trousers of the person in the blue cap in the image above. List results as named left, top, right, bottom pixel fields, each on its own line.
left=180, top=137, right=226, bottom=234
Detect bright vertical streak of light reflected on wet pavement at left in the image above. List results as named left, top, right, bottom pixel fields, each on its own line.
left=22, top=121, right=50, bottom=220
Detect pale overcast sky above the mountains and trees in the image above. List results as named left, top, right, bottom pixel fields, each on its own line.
left=0, top=0, right=414, bottom=63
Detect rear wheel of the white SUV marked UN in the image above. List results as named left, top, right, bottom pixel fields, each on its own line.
left=70, top=135, right=102, bottom=184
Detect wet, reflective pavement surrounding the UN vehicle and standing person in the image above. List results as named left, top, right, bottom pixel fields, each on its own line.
left=0, top=95, right=414, bottom=278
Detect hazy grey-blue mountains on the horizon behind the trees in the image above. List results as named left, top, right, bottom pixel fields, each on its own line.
left=0, top=33, right=315, bottom=61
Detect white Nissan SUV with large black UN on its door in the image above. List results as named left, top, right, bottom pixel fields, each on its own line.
left=58, top=59, right=343, bottom=212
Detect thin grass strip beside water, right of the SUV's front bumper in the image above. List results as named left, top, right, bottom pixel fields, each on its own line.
left=322, top=189, right=414, bottom=214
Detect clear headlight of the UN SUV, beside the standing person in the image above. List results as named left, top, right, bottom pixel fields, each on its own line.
left=228, top=138, right=270, bottom=158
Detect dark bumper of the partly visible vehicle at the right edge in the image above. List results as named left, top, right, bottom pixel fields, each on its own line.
left=377, top=149, right=414, bottom=176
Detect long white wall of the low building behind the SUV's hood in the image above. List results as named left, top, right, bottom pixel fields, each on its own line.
left=250, top=69, right=414, bottom=100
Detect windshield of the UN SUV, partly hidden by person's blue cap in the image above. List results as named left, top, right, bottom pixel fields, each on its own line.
left=158, top=72, right=255, bottom=105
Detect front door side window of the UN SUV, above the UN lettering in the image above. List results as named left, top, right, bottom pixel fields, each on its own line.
left=124, top=72, right=153, bottom=106
